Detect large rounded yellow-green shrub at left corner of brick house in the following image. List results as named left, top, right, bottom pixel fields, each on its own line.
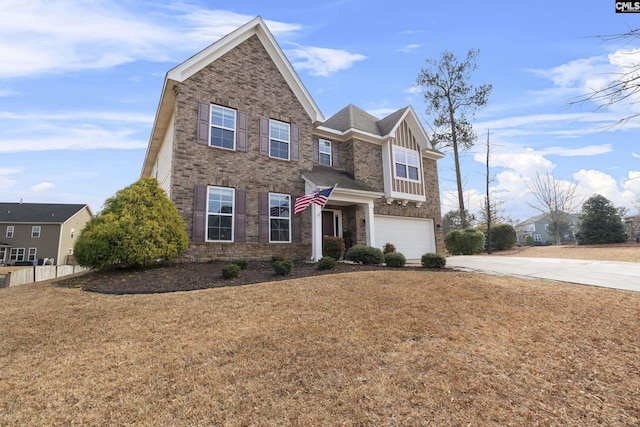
left=73, top=178, right=189, bottom=268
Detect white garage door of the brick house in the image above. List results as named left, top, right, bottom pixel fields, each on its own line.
left=375, top=215, right=436, bottom=259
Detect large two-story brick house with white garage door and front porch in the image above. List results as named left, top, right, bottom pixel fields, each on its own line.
left=141, top=17, right=444, bottom=261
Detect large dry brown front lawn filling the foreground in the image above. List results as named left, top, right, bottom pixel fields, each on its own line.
left=0, top=269, right=640, bottom=426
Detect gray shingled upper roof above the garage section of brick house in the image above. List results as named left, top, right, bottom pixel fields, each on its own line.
left=323, top=104, right=409, bottom=136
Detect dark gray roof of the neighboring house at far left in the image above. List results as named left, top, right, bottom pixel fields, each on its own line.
left=0, top=203, right=87, bottom=224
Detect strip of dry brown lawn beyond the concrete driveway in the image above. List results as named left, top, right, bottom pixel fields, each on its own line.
left=494, top=243, right=640, bottom=262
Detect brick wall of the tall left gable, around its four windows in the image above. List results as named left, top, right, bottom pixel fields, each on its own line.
left=171, top=36, right=312, bottom=261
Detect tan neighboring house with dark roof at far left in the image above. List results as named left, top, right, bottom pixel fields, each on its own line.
left=0, top=203, right=93, bottom=265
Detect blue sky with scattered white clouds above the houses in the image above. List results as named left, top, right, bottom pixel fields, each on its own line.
left=0, top=0, right=640, bottom=220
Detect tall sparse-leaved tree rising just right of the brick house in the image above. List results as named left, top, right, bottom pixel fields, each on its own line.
left=417, top=49, right=492, bottom=228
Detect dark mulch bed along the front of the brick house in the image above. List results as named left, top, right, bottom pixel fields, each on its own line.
left=56, top=261, right=396, bottom=294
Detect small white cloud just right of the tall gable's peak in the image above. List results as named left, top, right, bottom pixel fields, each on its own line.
left=287, top=46, right=367, bottom=77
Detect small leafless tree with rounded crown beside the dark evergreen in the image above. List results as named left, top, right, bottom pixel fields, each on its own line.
left=527, top=172, right=582, bottom=245
